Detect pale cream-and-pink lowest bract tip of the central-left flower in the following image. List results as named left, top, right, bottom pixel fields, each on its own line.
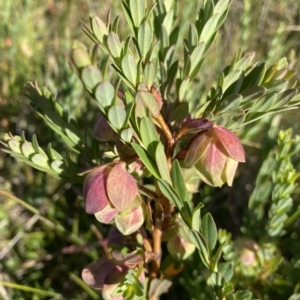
left=115, top=206, right=144, bottom=235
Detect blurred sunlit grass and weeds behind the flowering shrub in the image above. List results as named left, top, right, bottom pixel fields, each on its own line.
left=0, top=0, right=300, bottom=299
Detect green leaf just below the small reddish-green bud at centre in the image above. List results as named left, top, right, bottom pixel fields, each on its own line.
left=140, top=117, right=159, bottom=158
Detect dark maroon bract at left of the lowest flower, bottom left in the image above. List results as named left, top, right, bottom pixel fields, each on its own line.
left=81, top=258, right=115, bottom=289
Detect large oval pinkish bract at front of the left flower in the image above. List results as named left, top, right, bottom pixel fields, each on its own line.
left=107, top=163, right=138, bottom=212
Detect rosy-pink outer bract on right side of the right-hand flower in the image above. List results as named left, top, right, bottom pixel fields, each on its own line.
left=212, top=126, right=245, bottom=162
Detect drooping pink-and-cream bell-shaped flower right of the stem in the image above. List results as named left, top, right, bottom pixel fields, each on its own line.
left=185, top=126, right=245, bottom=186
